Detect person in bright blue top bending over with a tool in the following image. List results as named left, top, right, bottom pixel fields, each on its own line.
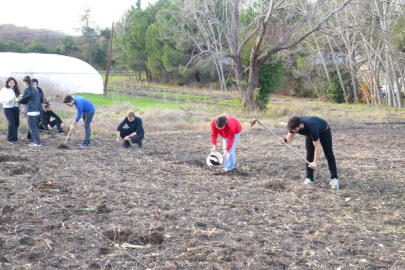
left=63, top=95, right=96, bottom=148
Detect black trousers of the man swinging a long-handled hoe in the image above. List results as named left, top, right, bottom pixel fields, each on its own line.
left=305, top=128, right=338, bottom=180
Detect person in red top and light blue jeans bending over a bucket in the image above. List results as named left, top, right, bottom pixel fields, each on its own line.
left=211, top=114, right=242, bottom=172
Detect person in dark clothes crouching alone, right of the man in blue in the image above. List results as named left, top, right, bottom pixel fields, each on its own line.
left=117, top=111, right=145, bottom=148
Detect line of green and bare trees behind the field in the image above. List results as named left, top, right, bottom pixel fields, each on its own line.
left=0, top=0, right=405, bottom=110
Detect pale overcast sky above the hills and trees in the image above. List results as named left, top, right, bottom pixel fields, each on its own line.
left=0, top=0, right=156, bottom=35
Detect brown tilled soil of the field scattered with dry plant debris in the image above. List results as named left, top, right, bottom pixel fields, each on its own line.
left=0, top=125, right=405, bottom=270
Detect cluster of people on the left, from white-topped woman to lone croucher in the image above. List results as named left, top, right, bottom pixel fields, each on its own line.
left=0, top=76, right=144, bottom=148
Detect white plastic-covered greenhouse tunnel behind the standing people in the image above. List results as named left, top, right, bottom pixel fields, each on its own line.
left=0, top=53, right=103, bottom=94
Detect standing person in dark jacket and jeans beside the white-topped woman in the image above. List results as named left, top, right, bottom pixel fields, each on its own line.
left=19, top=76, right=42, bottom=146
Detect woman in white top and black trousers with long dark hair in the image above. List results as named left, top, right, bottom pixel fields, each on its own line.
left=0, top=77, right=21, bottom=144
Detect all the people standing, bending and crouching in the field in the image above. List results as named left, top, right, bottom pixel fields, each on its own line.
left=0, top=76, right=339, bottom=189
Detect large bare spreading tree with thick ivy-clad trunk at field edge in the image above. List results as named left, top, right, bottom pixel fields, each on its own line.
left=167, top=0, right=351, bottom=110
